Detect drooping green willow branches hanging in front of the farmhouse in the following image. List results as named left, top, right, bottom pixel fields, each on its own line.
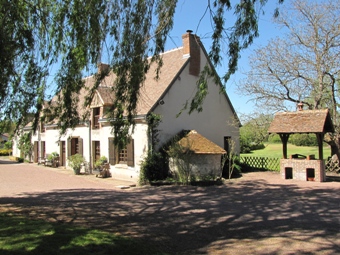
left=0, top=0, right=283, bottom=143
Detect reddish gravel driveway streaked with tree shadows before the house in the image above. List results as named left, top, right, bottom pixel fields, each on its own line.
left=0, top=160, right=340, bottom=254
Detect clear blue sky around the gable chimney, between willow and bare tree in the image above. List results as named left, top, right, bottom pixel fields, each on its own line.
left=166, top=0, right=291, bottom=115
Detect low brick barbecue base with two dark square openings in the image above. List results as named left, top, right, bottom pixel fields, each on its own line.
left=280, top=159, right=326, bottom=182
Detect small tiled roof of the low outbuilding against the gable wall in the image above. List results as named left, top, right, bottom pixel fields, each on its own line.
left=178, top=130, right=226, bottom=154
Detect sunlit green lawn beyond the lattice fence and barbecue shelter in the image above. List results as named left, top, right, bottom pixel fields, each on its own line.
left=241, top=143, right=331, bottom=159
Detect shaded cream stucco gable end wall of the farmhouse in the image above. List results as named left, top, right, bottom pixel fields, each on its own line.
left=155, top=46, right=240, bottom=153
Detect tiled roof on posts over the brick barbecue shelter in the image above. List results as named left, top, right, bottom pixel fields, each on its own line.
left=268, top=109, right=334, bottom=134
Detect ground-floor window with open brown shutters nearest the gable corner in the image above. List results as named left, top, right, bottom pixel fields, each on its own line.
left=108, top=137, right=135, bottom=167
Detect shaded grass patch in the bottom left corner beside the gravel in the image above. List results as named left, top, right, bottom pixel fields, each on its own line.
left=0, top=213, right=165, bottom=255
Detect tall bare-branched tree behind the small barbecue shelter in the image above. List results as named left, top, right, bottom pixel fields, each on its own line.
left=240, top=0, right=340, bottom=159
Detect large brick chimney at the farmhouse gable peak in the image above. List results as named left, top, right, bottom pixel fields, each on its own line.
left=182, top=30, right=201, bottom=76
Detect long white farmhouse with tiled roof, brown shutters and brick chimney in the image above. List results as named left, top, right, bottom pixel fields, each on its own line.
left=13, top=31, right=239, bottom=181
